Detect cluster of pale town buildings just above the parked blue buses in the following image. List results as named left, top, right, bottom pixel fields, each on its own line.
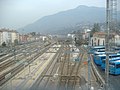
left=67, top=29, right=120, bottom=46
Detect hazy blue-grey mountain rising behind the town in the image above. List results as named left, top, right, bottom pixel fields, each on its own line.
left=18, top=5, right=119, bottom=33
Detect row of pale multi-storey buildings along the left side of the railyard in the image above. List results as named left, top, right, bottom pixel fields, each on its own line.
left=0, top=28, right=51, bottom=46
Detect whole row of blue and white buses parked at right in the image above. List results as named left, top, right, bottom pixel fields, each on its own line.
left=90, top=46, right=120, bottom=75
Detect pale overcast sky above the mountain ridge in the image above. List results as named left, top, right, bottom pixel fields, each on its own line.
left=0, top=0, right=116, bottom=29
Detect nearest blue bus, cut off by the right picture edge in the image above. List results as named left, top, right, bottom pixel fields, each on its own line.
left=109, top=60, right=120, bottom=75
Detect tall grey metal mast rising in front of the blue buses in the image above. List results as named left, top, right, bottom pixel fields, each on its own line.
left=105, top=0, right=110, bottom=90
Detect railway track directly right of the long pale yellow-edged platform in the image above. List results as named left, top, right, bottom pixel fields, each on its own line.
left=30, top=44, right=61, bottom=90
